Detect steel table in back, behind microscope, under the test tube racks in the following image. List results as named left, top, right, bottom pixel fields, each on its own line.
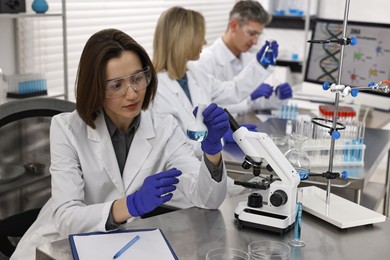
left=223, top=117, right=390, bottom=216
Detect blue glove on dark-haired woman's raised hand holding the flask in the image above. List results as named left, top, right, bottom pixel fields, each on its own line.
left=193, top=103, right=230, bottom=155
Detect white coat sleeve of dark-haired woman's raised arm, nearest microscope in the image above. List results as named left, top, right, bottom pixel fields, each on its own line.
left=161, top=116, right=227, bottom=209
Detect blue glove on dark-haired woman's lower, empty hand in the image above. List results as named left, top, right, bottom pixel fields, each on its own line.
left=126, top=168, right=181, bottom=217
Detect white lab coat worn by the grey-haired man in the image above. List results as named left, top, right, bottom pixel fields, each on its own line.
left=194, top=37, right=281, bottom=112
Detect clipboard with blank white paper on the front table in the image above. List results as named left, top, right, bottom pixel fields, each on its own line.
left=69, top=228, right=179, bottom=260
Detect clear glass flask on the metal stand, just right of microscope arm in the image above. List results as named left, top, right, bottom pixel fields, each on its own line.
left=284, top=133, right=310, bottom=180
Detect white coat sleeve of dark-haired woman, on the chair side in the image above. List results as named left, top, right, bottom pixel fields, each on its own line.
left=50, top=117, right=113, bottom=235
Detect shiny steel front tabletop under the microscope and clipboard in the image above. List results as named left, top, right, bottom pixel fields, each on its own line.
left=36, top=196, right=390, bottom=260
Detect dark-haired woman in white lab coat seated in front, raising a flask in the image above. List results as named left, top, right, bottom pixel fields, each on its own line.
left=11, top=29, right=229, bottom=260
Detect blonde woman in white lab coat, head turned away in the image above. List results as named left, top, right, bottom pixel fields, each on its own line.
left=153, top=7, right=270, bottom=156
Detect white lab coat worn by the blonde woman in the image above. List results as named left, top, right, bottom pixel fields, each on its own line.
left=153, top=58, right=270, bottom=157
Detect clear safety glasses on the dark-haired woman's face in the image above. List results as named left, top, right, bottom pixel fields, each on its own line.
left=106, top=66, right=152, bottom=98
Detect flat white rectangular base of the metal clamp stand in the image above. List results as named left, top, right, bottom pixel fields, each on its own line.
left=301, top=186, right=386, bottom=229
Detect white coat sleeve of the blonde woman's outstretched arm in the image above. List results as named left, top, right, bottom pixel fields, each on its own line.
left=188, top=58, right=272, bottom=106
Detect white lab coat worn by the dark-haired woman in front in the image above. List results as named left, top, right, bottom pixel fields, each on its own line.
left=11, top=108, right=226, bottom=260
